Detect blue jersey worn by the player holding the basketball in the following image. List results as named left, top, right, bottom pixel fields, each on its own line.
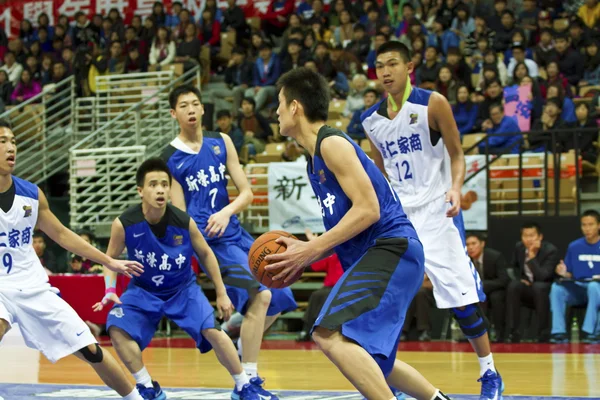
left=307, top=126, right=418, bottom=270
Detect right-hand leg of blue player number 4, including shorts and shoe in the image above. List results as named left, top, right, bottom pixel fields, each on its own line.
left=164, top=284, right=256, bottom=400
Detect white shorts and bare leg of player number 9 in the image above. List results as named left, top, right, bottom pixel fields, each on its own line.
left=0, top=289, right=142, bottom=400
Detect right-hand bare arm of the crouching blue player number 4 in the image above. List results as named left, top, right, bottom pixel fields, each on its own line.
left=190, top=218, right=233, bottom=321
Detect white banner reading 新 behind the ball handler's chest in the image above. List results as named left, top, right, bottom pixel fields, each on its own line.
left=269, top=162, right=325, bottom=234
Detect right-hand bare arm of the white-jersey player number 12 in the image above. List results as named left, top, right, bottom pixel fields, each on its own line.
left=429, top=92, right=466, bottom=217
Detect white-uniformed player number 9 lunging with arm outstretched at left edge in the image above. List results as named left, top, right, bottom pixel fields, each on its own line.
left=0, top=121, right=143, bottom=400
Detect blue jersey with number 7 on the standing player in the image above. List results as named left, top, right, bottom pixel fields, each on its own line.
left=162, top=131, right=241, bottom=243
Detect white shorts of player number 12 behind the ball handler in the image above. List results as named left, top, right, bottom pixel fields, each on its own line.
left=404, top=196, right=485, bottom=309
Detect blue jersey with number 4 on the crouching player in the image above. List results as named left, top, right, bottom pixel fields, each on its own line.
left=119, top=204, right=194, bottom=298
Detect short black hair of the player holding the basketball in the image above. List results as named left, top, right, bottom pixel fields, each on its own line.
left=277, top=67, right=330, bottom=122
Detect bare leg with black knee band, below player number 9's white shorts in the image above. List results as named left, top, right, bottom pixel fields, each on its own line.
left=73, top=342, right=143, bottom=400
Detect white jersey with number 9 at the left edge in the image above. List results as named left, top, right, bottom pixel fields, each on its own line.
left=0, top=176, right=48, bottom=290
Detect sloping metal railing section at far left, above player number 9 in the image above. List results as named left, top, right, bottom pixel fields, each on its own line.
left=0, top=76, right=75, bottom=184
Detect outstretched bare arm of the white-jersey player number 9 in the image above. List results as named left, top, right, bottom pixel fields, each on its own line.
left=38, top=189, right=144, bottom=277
